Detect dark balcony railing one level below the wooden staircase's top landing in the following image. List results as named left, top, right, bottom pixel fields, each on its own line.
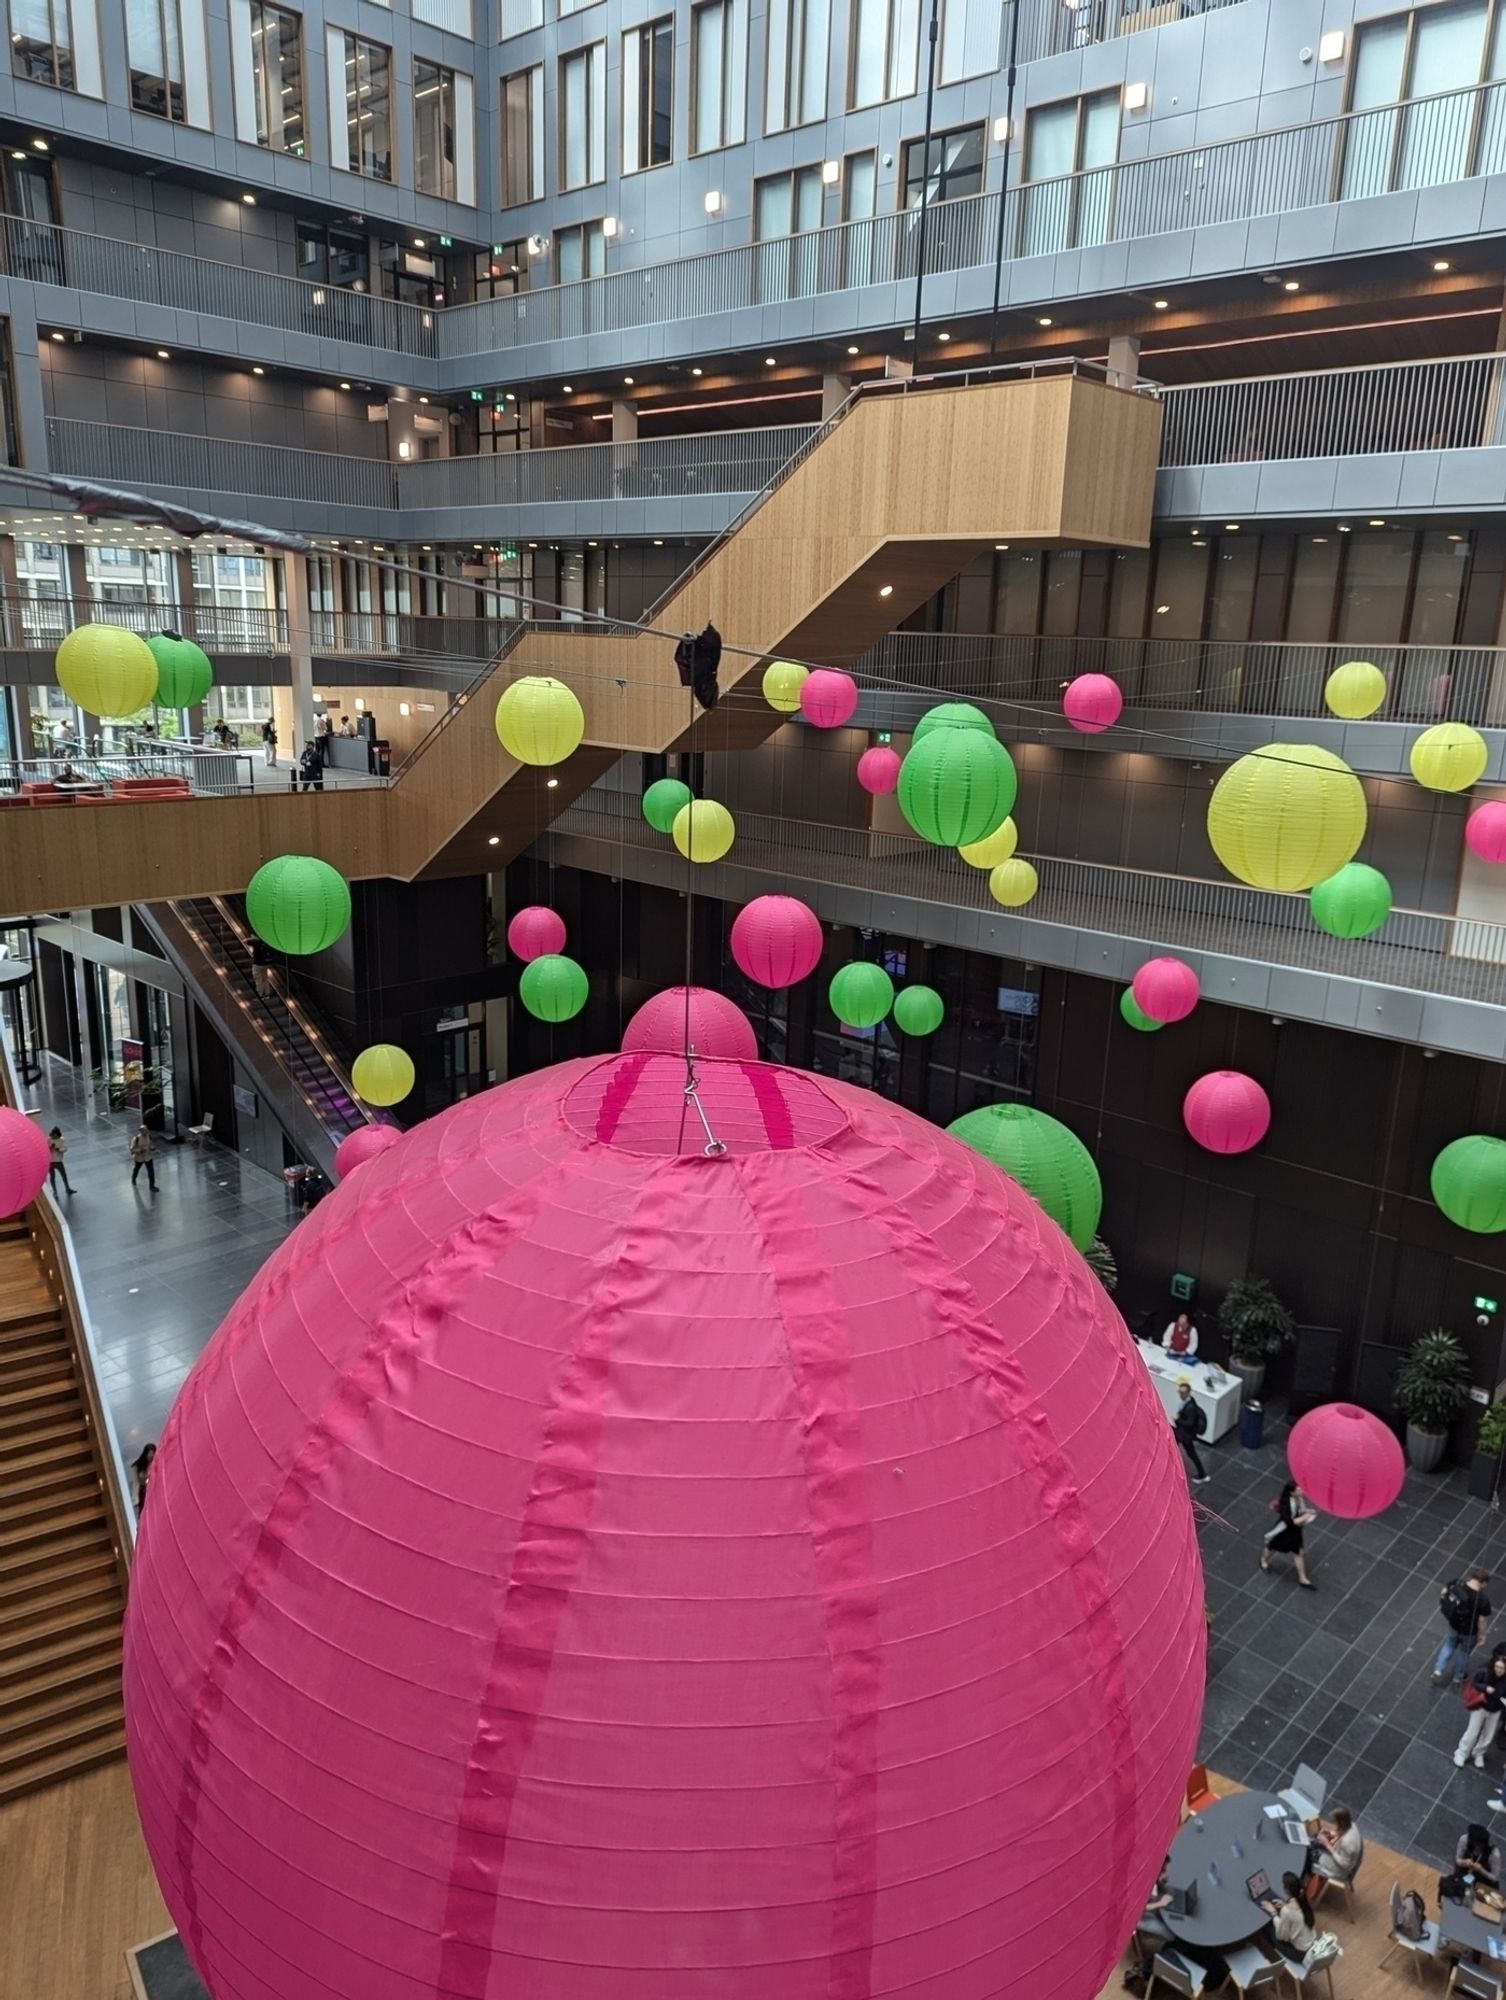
left=852, top=632, right=1506, bottom=728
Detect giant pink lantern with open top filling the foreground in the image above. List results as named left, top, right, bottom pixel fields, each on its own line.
left=126, top=1054, right=1206, bottom=2000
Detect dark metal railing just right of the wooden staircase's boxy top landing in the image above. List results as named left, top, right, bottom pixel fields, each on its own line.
left=1160, top=354, right=1506, bottom=466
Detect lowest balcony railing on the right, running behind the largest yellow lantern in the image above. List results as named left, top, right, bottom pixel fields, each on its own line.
left=554, top=788, right=1506, bottom=1006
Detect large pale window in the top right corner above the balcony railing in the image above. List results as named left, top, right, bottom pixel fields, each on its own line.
left=1338, top=0, right=1506, bottom=200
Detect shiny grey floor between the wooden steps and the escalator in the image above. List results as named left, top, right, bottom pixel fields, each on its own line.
left=24, top=1058, right=294, bottom=1458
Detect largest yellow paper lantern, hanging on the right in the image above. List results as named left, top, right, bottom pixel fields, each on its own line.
left=1208, top=744, right=1366, bottom=890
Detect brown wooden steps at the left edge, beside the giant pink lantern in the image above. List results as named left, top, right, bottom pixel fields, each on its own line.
left=0, top=1216, right=126, bottom=1802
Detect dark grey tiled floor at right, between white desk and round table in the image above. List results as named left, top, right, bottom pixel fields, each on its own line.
left=1194, top=1422, right=1506, bottom=1864
